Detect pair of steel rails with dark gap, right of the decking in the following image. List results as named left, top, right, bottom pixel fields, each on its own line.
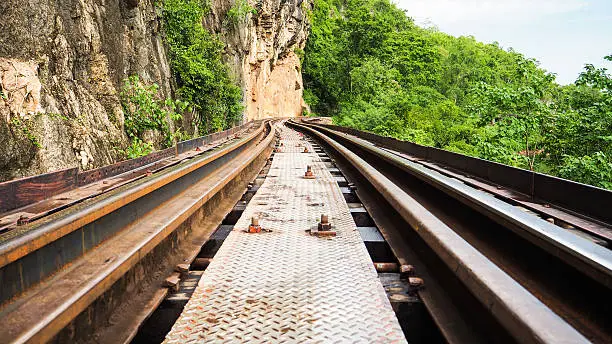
left=292, top=119, right=612, bottom=343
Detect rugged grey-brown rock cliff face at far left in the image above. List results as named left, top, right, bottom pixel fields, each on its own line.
left=0, top=0, right=171, bottom=180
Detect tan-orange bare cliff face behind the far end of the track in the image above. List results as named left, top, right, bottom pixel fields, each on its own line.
left=205, top=0, right=312, bottom=120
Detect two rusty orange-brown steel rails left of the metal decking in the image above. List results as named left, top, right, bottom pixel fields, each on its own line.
left=0, top=121, right=275, bottom=343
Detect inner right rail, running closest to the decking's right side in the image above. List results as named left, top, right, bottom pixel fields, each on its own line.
left=292, top=123, right=589, bottom=343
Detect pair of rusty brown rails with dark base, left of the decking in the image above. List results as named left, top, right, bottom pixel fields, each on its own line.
left=0, top=121, right=275, bottom=343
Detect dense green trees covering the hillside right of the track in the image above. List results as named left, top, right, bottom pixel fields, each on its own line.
left=303, top=0, right=612, bottom=188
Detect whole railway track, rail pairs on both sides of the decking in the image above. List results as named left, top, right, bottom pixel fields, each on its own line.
left=0, top=121, right=612, bottom=343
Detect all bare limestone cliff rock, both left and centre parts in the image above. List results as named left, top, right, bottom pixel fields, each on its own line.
left=0, top=0, right=312, bottom=181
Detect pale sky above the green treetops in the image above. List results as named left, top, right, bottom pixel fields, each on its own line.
left=395, top=0, right=612, bottom=84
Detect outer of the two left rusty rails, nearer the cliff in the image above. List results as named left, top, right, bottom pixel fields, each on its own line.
left=0, top=122, right=269, bottom=304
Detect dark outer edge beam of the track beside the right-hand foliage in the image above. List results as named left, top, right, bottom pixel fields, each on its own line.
left=308, top=119, right=612, bottom=247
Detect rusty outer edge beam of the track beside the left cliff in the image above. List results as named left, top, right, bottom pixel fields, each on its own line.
left=0, top=122, right=255, bottom=233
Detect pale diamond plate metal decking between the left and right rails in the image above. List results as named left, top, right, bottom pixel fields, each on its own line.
left=165, top=127, right=406, bottom=343
